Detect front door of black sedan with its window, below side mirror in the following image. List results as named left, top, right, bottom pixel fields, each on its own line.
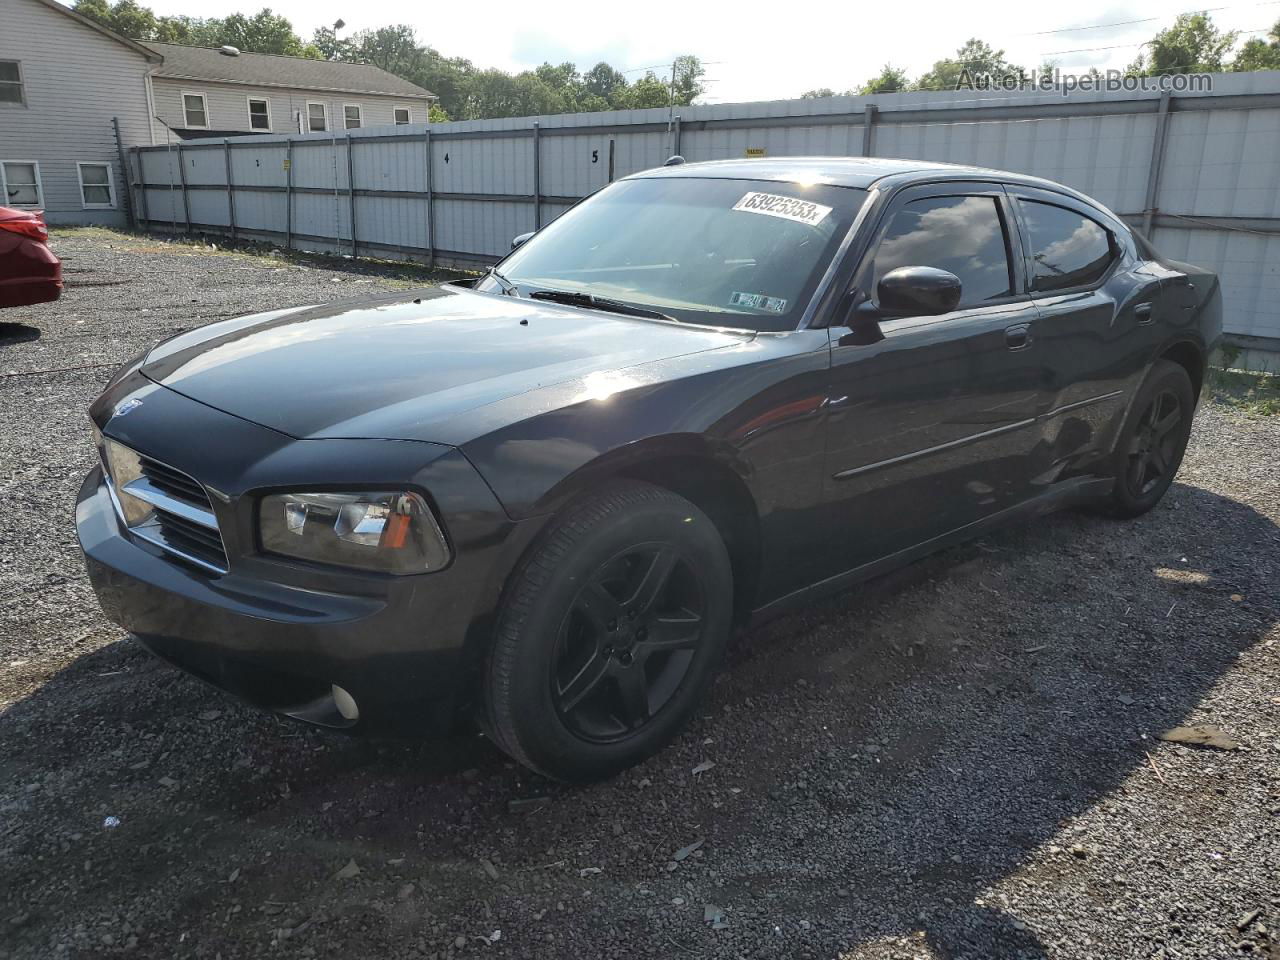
left=823, top=182, right=1047, bottom=572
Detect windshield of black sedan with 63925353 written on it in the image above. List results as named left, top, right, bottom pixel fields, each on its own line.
left=476, top=177, right=867, bottom=330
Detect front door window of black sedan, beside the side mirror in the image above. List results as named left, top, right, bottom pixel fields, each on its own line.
left=872, top=196, right=1012, bottom=308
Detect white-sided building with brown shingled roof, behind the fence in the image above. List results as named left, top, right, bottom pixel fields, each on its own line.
left=0, top=0, right=435, bottom=227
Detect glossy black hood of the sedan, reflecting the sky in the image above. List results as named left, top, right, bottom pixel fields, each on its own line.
left=142, top=287, right=750, bottom=440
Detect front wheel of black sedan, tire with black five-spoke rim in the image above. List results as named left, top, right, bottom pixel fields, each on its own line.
left=483, top=481, right=733, bottom=782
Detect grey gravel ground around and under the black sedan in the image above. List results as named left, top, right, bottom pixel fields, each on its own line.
left=0, top=232, right=1280, bottom=960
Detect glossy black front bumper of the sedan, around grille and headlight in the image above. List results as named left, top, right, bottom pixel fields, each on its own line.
left=76, top=376, right=535, bottom=736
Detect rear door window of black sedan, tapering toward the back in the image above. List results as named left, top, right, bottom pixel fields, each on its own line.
left=1018, top=200, right=1115, bottom=293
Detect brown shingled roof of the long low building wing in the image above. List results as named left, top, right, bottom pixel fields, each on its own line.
left=144, top=42, right=435, bottom=100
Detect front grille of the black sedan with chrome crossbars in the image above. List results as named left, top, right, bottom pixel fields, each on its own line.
left=102, top=438, right=227, bottom=573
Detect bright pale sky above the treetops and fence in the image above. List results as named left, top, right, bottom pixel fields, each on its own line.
left=140, top=0, right=1280, bottom=102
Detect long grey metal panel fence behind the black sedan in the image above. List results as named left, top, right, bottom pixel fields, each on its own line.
left=131, top=72, right=1280, bottom=351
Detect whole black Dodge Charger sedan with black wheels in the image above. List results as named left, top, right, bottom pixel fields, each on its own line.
left=76, top=157, right=1221, bottom=781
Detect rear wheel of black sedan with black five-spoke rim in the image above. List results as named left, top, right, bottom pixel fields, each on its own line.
left=1110, top=360, right=1196, bottom=518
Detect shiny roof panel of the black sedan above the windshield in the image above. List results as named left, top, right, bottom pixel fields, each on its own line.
left=627, top=156, right=1096, bottom=198
